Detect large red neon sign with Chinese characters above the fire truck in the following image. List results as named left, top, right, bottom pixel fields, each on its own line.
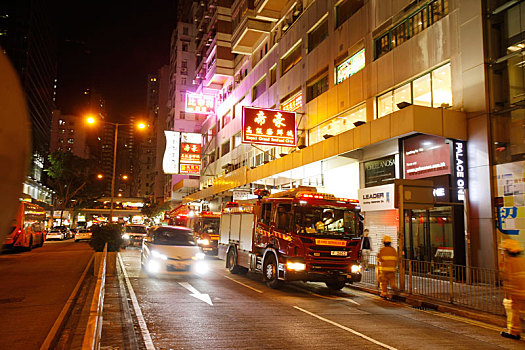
left=242, top=107, right=297, bottom=147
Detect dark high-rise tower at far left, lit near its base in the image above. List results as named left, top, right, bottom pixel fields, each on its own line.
left=0, top=0, right=57, bottom=204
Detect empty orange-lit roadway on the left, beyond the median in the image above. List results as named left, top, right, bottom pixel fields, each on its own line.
left=0, top=239, right=93, bottom=350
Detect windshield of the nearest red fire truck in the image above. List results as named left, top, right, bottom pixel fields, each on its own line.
left=295, top=205, right=357, bottom=238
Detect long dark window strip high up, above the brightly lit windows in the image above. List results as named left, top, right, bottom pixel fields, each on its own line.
left=374, top=0, right=448, bottom=59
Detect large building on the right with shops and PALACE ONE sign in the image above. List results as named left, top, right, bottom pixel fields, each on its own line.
left=179, top=0, right=525, bottom=268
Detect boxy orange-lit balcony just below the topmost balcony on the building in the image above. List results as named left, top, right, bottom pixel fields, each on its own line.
left=232, top=16, right=272, bottom=55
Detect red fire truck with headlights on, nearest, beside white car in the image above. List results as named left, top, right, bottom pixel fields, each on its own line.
left=218, top=186, right=361, bottom=290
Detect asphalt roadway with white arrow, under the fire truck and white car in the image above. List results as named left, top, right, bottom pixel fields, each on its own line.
left=120, top=249, right=525, bottom=350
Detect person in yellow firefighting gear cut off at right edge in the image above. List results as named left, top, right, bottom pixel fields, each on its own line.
left=501, top=239, right=525, bottom=340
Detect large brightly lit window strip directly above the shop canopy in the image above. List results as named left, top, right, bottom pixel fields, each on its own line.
left=377, top=63, right=452, bottom=118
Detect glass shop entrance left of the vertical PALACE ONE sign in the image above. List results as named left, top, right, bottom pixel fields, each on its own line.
left=405, top=204, right=465, bottom=265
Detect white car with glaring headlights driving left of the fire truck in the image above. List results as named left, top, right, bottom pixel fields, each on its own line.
left=140, top=226, right=208, bottom=275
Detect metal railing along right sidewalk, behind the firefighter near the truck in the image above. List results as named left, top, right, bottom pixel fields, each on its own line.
left=360, top=256, right=505, bottom=315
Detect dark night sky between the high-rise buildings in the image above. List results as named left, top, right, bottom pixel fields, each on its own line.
left=57, top=0, right=177, bottom=120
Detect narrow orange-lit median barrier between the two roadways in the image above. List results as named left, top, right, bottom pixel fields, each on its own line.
left=82, top=243, right=108, bottom=349
